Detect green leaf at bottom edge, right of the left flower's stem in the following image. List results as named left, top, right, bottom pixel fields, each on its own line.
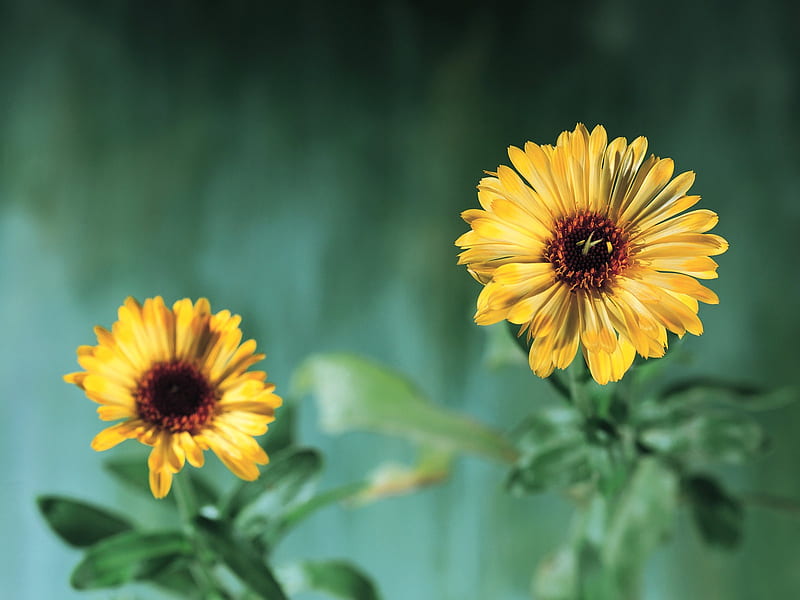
left=278, top=560, right=380, bottom=600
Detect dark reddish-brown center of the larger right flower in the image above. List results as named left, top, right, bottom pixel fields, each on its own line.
left=544, top=212, right=630, bottom=292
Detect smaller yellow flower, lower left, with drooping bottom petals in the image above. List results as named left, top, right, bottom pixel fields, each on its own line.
left=64, top=297, right=281, bottom=498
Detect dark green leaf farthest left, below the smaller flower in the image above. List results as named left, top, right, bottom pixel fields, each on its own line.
left=36, top=496, right=133, bottom=548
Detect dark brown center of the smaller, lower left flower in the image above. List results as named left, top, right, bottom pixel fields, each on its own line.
left=136, top=361, right=216, bottom=433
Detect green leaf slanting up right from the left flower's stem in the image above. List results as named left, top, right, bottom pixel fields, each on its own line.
left=222, top=448, right=322, bottom=519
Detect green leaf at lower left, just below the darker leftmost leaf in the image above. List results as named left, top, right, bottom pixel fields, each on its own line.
left=70, top=531, right=193, bottom=590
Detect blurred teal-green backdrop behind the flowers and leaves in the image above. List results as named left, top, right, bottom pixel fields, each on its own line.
left=0, top=0, right=800, bottom=600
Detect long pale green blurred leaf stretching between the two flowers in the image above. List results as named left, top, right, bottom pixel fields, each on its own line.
left=293, top=354, right=516, bottom=461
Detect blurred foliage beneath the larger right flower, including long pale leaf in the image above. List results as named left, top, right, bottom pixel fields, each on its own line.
left=295, top=340, right=796, bottom=600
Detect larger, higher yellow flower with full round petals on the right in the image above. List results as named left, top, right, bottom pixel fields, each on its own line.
left=456, top=124, right=728, bottom=384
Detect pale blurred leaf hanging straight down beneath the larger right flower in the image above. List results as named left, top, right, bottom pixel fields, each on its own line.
left=602, top=458, right=678, bottom=581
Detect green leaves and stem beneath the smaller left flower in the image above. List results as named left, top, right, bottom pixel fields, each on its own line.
left=37, top=404, right=380, bottom=600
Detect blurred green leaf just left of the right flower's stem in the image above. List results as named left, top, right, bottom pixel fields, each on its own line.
left=507, top=408, right=592, bottom=494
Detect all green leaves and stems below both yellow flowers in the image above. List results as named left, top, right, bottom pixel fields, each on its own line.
left=38, top=338, right=795, bottom=600
